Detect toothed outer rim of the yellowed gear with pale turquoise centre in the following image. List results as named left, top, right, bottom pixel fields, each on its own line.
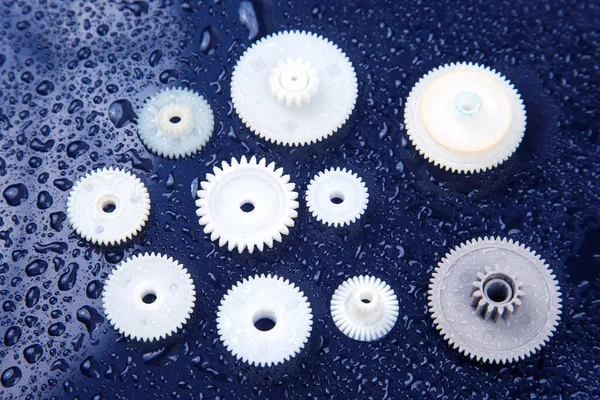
left=404, top=62, right=527, bottom=174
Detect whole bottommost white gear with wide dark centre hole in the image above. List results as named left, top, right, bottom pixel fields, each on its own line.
left=217, top=274, right=312, bottom=367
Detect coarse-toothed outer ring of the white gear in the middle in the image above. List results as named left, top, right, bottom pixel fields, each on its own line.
left=196, top=156, right=299, bottom=254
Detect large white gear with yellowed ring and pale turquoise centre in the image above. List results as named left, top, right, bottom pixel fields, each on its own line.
left=404, top=63, right=527, bottom=173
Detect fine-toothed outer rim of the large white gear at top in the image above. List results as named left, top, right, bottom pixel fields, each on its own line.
left=231, top=30, right=358, bottom=146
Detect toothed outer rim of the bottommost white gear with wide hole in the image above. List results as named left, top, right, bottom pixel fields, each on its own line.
left=217, top=274, right=313, bottom=367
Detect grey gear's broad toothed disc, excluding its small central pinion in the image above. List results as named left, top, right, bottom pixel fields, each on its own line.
left=428, top=237, right=562, bottom=364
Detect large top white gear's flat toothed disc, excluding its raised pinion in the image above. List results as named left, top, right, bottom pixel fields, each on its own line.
left=231, top=31, right=358, bottom=146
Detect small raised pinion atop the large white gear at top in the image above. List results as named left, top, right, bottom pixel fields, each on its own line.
left=269, top=57, right=319, bottom=107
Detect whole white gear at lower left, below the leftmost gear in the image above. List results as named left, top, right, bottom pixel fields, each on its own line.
left=102, top=253, right=196, bottom=342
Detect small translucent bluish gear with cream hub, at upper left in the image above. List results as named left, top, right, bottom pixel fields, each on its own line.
left=138, top=88, right=215, bottom=159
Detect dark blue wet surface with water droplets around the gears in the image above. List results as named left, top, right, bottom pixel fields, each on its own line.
left=0, top=0, right=600, bottom=399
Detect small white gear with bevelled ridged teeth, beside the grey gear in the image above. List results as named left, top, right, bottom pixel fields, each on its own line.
left=331, top=275, right=399, bottom=342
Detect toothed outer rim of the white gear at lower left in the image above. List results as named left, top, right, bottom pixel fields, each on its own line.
left=102, top=252, right=196, bottom=342
